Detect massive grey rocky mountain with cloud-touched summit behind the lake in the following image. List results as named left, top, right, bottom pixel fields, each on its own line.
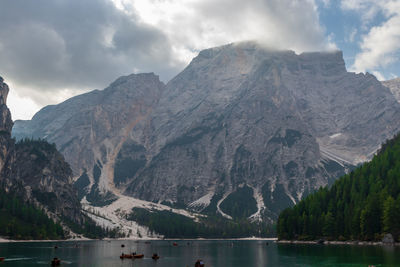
left=13, top=42, right=400, bottom=223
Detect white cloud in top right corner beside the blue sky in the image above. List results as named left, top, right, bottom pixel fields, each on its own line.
left=342, top=0, right=400, bottom=75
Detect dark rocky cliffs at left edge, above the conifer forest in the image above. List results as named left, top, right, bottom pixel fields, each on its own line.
left=0, top=78, right=83, bottom=223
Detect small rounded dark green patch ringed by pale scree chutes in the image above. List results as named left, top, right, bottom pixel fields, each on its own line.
left=220, top=186, right=257, bottom=219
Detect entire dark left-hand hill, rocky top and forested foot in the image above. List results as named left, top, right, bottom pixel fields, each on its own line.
left=0, top=77, right=103, bottom=239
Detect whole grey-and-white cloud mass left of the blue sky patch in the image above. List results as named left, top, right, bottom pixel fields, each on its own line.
left=0, top=0, right=336, bottom=118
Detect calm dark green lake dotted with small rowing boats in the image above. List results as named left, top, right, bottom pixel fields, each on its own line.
left=0, top=240, right=400, bottom=267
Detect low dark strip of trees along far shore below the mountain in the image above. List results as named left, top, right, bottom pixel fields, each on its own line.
left=128, top=208, right=274, bottom=238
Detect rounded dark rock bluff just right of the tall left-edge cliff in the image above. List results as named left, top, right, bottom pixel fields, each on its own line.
left=12, top=140, right=82, bottom=223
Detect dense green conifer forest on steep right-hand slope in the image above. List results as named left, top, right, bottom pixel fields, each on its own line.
left=277, top=135, right=400, bottom=241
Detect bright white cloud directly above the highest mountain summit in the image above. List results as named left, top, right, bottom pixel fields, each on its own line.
left=126, top=0, right=336, bottom=60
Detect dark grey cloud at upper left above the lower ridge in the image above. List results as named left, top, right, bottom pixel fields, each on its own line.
left=0, top=0, right=177, bottom=108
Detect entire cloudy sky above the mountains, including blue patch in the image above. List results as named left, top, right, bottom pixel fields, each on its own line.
left=0, top=0, right=400, bottom=119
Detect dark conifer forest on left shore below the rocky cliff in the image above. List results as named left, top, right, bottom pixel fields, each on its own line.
left=0, top=190, right=65, bottom=239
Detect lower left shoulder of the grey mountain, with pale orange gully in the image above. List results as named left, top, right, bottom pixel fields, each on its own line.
left=13, top=73, right=164, bottom=205
